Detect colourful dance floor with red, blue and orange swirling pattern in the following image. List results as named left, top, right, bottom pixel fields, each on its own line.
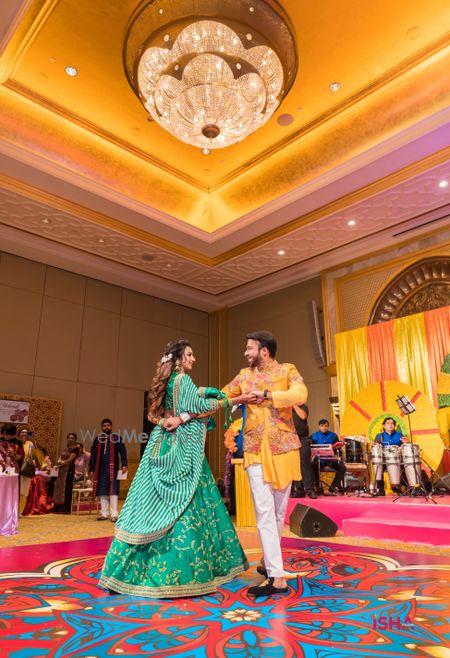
left=0, top=538, right=450, bottom=658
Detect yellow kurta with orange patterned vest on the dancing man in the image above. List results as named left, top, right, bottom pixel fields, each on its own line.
left=223, top=361, right=308, bottom=489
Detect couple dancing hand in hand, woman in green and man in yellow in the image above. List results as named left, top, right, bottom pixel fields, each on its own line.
left=100, top=332, right=306, bottom=598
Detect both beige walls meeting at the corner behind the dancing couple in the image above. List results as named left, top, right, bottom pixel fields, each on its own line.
left=0, top=253, right=331, bottom=476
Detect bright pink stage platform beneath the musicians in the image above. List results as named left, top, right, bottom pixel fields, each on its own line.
left=286, top=495, right=450, bottom=546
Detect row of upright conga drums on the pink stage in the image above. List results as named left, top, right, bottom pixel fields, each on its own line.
left=344, top=435, right=422, bottom=493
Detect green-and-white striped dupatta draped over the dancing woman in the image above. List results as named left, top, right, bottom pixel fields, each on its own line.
left=116, top=374, right=224, bottom=544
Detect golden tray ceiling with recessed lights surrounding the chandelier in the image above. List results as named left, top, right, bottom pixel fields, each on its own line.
left=0, top=0, right=450, bottom=310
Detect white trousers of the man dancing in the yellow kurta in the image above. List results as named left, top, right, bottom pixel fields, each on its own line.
left=247, top=464, right=291, bottom=578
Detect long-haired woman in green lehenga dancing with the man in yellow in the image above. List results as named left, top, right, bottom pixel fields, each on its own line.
left=100, top=340, right=248, bottom=598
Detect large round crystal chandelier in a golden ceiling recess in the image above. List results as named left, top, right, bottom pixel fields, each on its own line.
left=124, top=0, right=297, bottom=153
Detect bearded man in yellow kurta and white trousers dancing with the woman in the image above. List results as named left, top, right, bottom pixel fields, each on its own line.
left=223, top=331, right=308, bottom=596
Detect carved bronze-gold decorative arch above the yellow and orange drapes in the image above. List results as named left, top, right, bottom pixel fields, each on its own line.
left=369, top=256, right=450, bottom=324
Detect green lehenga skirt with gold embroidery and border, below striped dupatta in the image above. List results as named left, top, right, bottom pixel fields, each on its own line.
left=100, top=458, right=248, bottom=598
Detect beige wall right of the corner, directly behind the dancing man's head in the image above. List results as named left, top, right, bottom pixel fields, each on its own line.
left=228, top=278, right=331, bottom=431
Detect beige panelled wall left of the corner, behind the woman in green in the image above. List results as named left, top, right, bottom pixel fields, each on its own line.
left=0, top=253, right=208, bottom=459
